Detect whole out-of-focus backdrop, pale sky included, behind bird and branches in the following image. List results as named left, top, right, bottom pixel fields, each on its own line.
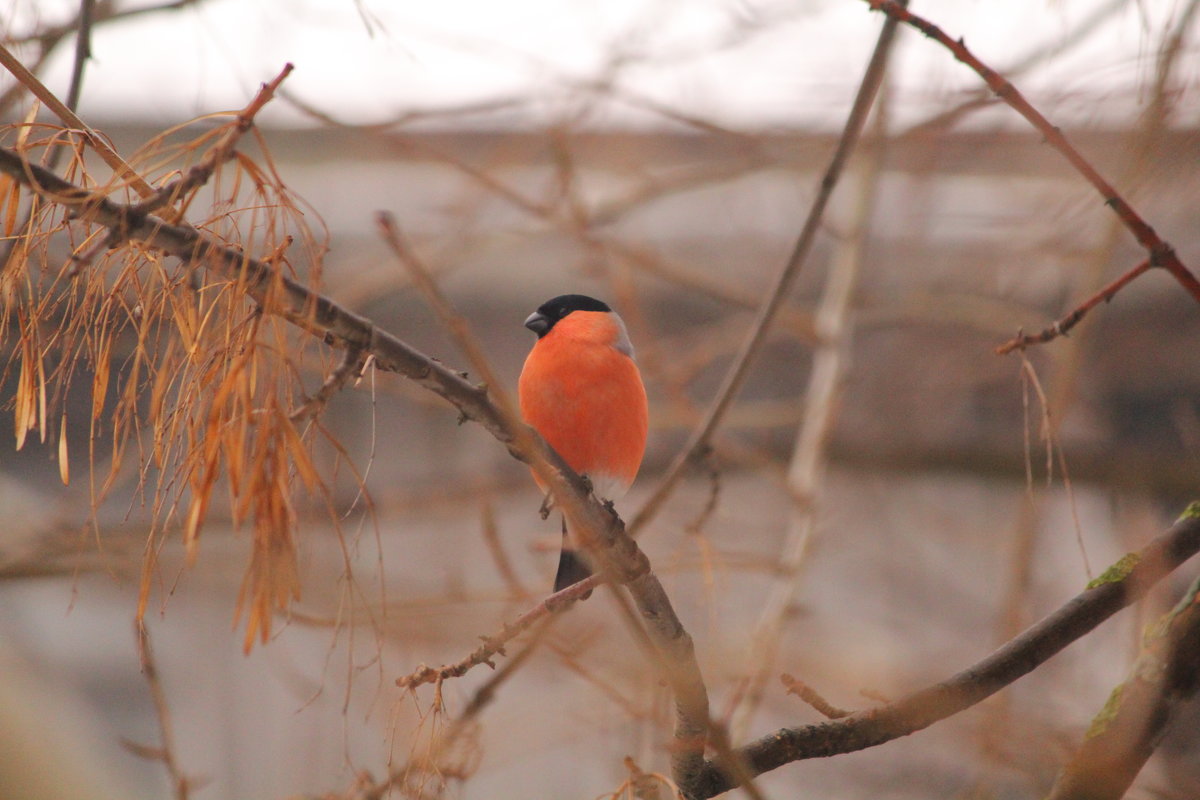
left=0, top=0, right=1200, bottom=800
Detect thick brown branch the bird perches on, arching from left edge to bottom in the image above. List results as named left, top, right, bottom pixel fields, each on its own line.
left=0, top=148, right=709, bottom=790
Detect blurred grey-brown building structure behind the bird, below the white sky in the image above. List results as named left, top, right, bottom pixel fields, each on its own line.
left=0, top=120, right=1200, bottom=800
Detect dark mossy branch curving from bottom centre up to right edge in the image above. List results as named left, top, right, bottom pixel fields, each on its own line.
left=689, top=513, right=1200, bottom=800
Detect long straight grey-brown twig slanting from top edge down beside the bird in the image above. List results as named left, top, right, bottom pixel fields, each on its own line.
left=629, top=3, right=896, bottom=536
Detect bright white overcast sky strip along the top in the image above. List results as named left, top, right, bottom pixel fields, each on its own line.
left=9, top=0, right=1200, bottom=127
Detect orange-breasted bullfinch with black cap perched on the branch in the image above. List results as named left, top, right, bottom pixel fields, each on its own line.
left=517, top=294, right=648, bottom=591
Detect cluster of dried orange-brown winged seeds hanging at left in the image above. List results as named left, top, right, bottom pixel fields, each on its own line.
left=0, top=104, right=333, bottom=649
